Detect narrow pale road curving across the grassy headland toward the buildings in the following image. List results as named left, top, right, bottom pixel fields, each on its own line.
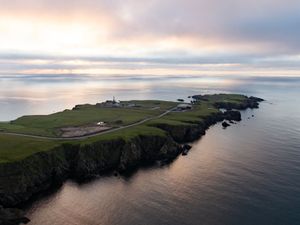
left=0, top=107, right=176, bottom=141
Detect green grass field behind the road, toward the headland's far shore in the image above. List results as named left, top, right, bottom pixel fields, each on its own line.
left=0, top=101, right=176, bottom=137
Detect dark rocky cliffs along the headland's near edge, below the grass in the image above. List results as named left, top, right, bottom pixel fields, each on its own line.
left=0, top=96, right=262, bottom=225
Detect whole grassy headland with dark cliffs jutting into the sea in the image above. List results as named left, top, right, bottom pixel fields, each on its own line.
left=0, top=94, right=263, bottom=224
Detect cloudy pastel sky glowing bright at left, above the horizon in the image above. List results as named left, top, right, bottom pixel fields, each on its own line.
left=0, top=0, right=300, bottom=76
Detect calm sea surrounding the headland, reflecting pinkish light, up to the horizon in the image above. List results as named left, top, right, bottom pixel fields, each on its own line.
left=0, top=76, right=300, bottom=225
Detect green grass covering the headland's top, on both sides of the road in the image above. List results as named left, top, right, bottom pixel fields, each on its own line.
left=0, top=94, right=246, bottom=163
